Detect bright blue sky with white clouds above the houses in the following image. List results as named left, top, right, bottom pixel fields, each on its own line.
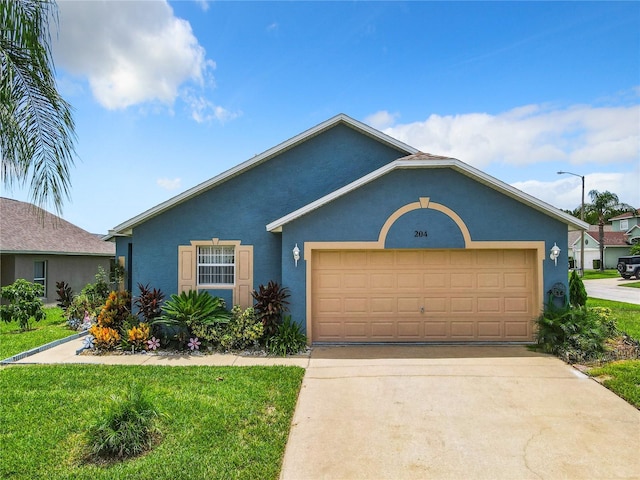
left=2, top=0, right=640, bottom=233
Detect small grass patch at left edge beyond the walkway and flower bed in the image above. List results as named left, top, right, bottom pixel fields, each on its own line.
left=0, top=307, right=76, bottom=360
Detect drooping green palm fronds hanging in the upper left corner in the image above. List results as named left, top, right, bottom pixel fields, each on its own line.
left=0, top=0, right=76, bottom=213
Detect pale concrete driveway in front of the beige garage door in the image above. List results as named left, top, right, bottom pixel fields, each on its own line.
left=281, top=346, right=640, bottom=480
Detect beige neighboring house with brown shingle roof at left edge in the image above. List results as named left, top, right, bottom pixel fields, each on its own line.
left=0, top=197, right=115, bottom=303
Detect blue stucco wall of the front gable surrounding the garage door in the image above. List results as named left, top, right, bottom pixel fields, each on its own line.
left=282, top=169, right=568, bottom=325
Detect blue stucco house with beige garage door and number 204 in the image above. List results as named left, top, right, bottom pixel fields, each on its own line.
left=106, top=115, right=587, bottom=343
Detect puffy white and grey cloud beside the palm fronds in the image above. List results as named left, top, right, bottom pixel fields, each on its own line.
left=54, top=1, right=215, bottom=109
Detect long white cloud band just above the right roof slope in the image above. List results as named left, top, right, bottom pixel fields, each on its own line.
left=380, top=101, right=640, bottom=168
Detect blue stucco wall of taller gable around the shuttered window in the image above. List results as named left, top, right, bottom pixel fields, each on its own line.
left=116, top=125, right=405, bottom=303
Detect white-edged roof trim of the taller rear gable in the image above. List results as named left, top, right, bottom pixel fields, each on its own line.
left=104, top=113, right=418, bottom=240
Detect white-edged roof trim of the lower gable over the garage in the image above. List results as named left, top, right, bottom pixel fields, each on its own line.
left=267, top=152, right=589, bottom=232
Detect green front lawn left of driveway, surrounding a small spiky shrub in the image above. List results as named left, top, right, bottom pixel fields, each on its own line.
left=0, top=365, right=304, bottom=480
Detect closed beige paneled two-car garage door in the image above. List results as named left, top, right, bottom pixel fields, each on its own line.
left=311, top=250, right=537, bottom=342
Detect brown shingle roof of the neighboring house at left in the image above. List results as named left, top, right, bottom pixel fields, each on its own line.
left=0, top=197, right=116, bottom=257
